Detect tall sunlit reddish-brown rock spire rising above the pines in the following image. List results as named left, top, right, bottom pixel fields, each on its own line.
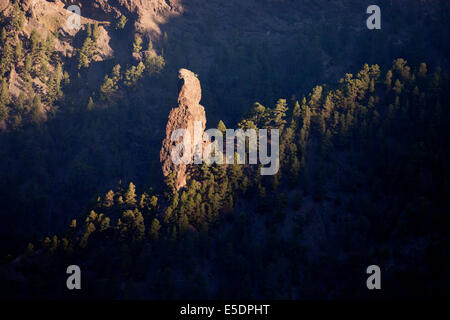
left=160, top=69, right=206, bottom=190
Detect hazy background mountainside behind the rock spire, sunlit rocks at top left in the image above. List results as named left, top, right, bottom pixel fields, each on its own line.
left=0, top=0, right=449, bottom=253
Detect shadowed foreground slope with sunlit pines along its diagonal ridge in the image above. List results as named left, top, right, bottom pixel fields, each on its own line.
left=0, top=59, right=450, bottom=299
